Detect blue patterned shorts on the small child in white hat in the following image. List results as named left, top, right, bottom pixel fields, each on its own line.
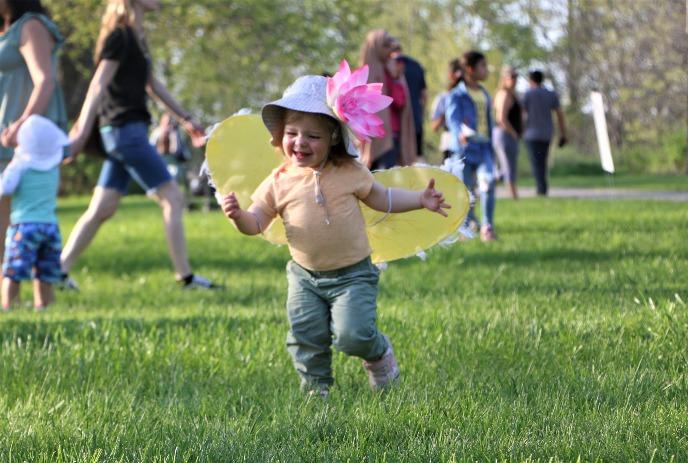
left=2, top=223, right=62, bottom=283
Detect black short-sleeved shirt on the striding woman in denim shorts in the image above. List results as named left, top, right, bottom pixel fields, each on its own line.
left=98, top=26, right=151, bottom=126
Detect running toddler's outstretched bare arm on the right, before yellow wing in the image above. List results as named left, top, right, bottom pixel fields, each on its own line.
left=362, top=179, right=451, bottom=217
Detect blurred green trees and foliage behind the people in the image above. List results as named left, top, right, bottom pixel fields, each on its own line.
left=44, top=0, right=688, bottom=183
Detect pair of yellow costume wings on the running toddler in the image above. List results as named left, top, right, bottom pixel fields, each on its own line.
left=206, top=115, right=469, bottom=263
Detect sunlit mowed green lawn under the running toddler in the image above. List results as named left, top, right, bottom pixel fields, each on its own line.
left=0, top=197, right=688, bottom=462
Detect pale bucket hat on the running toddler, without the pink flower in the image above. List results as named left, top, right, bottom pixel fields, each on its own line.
left=261, top=76, right=358, bottom=157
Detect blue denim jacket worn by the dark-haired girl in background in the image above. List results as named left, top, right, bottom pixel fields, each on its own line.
left=444, top=82, right=493, bottom=164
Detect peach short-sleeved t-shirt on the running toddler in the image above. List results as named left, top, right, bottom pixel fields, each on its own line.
left=251, top=159, right=374, bottom=271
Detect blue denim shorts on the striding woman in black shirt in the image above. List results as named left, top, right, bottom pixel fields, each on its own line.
left=98, top=122, right=172, bottom=194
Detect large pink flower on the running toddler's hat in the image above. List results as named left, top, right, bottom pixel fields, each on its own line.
left=327, top=60, right=392, bottom=142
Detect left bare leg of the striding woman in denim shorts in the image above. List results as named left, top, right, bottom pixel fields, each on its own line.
left=60, top=186, right=122, bottom=273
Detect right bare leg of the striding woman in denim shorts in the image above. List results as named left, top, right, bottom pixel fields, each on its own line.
left=153, top=180, right=191, bottom=279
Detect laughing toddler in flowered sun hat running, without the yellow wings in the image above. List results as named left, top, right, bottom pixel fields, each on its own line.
left=222, top=61, right=449, bottom=397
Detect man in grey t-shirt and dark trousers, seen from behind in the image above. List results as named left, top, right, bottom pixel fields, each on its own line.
left=523, top=70, right=567, bottom=196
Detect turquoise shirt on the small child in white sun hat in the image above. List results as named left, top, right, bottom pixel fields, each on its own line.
left=10, top=165, right=60, bottom=225
